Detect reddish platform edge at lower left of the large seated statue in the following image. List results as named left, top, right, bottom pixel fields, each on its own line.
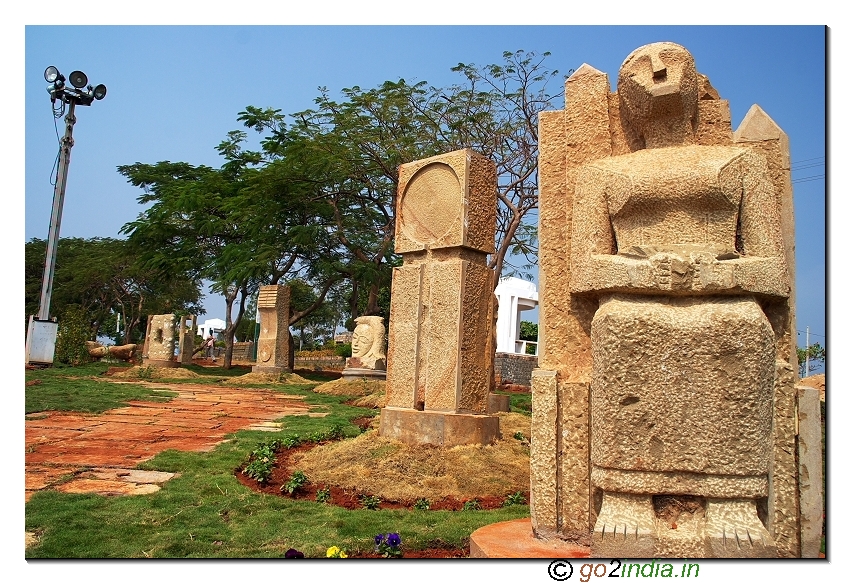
left=469, top=518, right=590, bottom=559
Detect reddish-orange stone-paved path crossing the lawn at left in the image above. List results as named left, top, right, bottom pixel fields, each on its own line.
left=25, top=381, right=326, bottom=500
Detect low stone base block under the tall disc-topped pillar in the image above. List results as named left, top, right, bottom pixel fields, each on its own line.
left=380, top=407, right=501, bottom=447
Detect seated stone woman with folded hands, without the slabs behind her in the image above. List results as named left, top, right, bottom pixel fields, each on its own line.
left=571, top=43, right=790, bottom=557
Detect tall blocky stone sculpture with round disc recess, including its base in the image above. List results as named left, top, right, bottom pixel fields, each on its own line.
left=380, top=149, right=499, bottom=445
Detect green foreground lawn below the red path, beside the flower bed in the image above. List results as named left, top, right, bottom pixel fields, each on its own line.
left=26, top=425, right=528, bottom=559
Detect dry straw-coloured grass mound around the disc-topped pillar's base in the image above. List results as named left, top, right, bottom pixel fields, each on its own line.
left=293, top=413, right=531, bottom=500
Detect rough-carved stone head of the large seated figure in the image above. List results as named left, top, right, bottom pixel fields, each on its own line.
left=617, top=42, right=699, bottom=148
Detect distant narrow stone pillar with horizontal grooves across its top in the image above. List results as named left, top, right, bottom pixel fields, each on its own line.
left=251, top=285, right=292, bottom=374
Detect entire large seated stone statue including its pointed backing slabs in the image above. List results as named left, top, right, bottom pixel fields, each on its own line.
left=531, top=43, right=820, bottom=557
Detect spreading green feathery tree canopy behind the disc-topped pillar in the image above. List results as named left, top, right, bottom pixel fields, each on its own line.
left=118, top=51, right=562, bottom=366
